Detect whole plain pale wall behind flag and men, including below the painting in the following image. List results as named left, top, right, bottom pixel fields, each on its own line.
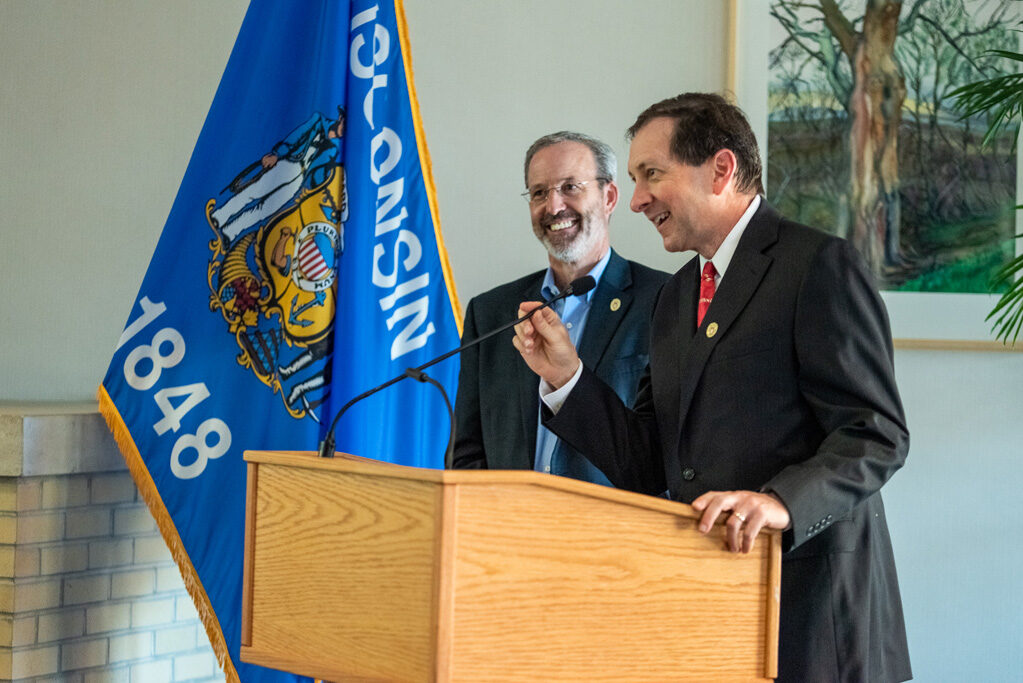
left=0, top=0, right=1023, bottom=681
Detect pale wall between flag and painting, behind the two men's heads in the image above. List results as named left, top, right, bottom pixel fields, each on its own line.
left=405, top=0, right=727, bottom=298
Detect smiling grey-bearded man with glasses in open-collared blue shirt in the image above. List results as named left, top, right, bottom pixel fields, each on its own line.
left=454, top=132, right=668, bottom=486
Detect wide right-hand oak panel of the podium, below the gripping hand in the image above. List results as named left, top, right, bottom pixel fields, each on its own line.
left=450, top=485, right=773, bottom=681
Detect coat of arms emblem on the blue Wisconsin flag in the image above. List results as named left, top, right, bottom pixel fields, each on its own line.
left=206, top=107, right=348, bottom=421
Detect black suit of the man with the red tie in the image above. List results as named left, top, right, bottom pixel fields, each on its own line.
left=545, top=203, right=911, bottom=683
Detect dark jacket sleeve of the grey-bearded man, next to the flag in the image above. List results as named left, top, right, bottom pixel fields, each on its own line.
left=452, top=299, right=487, bottom=469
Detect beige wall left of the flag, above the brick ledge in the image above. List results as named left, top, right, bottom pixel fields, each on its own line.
left=0, top=0, right=247, bottom=401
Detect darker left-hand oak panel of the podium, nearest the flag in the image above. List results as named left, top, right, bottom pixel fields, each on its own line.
left=243, top=462, right=440, bottom=681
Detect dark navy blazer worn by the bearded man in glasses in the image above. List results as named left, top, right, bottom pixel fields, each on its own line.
left=454, top=251, right=668, bottom=485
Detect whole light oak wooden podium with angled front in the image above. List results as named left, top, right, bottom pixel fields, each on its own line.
left=241, top=452, right=782, bottom=682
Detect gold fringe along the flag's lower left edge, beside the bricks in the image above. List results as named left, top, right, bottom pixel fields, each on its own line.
left=96, top=384, right=239, bottom=683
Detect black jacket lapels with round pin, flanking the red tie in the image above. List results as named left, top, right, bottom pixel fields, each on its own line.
left=678, top=205, right=779, bottom=435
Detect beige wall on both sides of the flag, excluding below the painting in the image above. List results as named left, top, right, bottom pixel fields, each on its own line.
left=0, top=0, right=726, bottom=401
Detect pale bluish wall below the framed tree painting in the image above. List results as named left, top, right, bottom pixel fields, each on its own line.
left=884, top=349, right=1023, bottom=682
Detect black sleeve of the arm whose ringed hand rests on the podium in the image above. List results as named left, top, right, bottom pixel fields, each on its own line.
left=763, top=239, right=909, bottom=549
